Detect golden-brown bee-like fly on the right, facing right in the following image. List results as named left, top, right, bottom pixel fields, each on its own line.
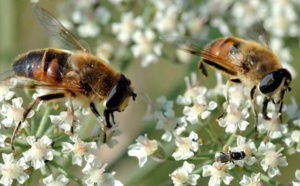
left=161, top=37, right=292, bottom=129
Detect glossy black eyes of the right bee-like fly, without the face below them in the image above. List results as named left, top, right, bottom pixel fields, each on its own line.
left=259, top=69, right=290, bottom=94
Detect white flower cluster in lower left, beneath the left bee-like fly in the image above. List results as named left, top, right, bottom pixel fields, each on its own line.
left=0, top=94, right=122, bottom=185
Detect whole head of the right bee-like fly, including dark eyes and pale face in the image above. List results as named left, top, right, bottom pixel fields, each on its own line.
left=258, top=68, right=292, bottom=104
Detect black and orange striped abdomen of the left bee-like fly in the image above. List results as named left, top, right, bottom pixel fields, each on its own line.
left=13, top=48, right=71, bottom=84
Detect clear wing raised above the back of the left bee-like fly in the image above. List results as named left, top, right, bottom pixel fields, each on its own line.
left=32, top=5, right=88, bottom=52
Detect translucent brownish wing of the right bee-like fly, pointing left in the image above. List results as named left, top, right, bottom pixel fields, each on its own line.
left=160, top=36, right=242, bottom=74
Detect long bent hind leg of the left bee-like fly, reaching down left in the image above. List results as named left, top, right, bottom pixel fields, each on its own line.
left=10, top=93, right=66, bottom=152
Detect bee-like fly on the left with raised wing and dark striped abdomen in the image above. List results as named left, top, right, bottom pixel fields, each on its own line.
left=7, top=5, right=137, bottom=150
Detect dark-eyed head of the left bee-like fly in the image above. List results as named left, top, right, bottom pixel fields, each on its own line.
left=104, top=74, right=137, bottom=128
